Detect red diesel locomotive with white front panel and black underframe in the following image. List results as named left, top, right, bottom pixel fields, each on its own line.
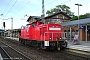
left=19, top=22, right=67, bottom=50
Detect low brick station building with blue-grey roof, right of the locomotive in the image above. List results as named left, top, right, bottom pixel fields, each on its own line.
left=62, top=18, right=90, bottom=42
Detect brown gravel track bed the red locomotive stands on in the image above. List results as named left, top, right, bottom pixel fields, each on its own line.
left=0, top=39, right=90, bottom=60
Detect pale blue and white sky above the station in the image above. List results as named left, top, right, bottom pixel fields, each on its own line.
left=0, top=0, right=90, bottom=29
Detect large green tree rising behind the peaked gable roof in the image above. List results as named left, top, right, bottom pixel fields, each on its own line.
left=46, top=5, right=74, bottom=16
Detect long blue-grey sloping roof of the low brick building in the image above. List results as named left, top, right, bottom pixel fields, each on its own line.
left=62, top=18, right=90, bottom=26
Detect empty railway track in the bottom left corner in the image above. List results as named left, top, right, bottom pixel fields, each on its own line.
left=0, top=41, right=32, bottom=60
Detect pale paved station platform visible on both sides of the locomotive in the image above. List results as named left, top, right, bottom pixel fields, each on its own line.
left=6, top=37, right=90, bottom=52
